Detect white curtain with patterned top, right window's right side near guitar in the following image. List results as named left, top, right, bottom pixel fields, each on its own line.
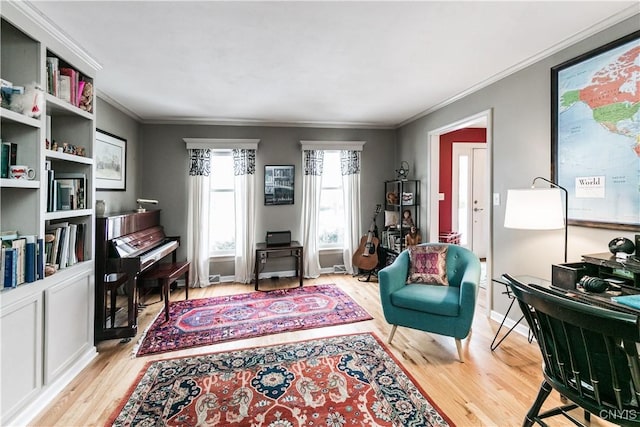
left=340, top=150, right=361, bottom=274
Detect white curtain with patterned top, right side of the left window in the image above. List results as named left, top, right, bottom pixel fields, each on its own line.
left=233, top=148, right=256, bottom=283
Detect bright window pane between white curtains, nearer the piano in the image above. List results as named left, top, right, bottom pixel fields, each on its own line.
left=209, top=150, right=236, bottom=256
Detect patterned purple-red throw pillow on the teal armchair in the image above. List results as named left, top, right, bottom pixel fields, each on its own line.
left=407, top=246, right=449, bottom=286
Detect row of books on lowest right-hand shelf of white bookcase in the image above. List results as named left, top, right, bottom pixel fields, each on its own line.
left=44, top=221, right=85, bottom=270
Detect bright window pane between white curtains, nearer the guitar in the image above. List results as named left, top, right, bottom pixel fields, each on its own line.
left=318, top=150, right=345, bottom=249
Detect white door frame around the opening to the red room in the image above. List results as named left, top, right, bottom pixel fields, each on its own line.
left=426, top=108, right=493, bottom=316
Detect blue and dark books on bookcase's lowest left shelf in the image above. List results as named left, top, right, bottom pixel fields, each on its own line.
left=0, top=231, right=45, bottom=288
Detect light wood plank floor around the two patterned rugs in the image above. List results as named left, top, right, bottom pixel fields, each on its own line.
left=32, top=275, right=605, bottom=427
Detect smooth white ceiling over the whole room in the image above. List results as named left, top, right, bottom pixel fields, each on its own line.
left=28, top=1, right=640, bottom=127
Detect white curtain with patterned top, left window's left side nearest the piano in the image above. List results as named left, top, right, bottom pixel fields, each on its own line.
left=186, top=149, right=211, bottom=288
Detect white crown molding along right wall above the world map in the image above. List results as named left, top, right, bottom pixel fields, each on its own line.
left=394, top=3, right=640, bottom=129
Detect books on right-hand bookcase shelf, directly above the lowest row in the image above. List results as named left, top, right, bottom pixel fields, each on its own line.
left=47, top=169, right=87, bottom=212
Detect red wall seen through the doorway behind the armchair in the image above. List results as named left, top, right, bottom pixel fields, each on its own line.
left=439, top=128, right=487, bottom=233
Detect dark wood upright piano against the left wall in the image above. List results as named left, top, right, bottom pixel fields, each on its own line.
left=94, top=210, right=179, bottom=341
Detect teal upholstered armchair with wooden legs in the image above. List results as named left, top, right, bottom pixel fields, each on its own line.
left=378, top=243, right=480, bottom=362
